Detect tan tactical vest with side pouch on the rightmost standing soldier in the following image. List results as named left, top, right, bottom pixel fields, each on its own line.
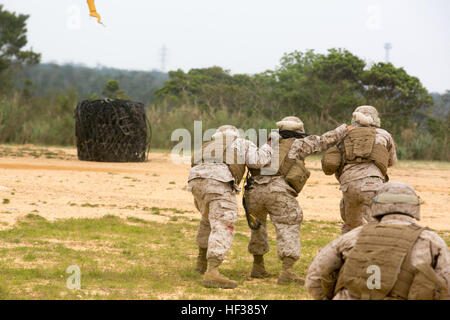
left=322, top=127, right=389, bottom=176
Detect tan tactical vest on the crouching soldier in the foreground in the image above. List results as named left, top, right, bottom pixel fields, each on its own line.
left=334, top=223, right=425, bottom=300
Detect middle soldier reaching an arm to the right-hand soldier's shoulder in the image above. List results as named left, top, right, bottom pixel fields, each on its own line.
left=244, top=117, right=348, bottom=284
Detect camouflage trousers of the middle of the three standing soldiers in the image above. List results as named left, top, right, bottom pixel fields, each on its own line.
left=245, top=182, right=303, bottom=260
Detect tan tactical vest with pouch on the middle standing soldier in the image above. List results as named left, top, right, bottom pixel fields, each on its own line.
left=250, top=138, right=310, bottom=193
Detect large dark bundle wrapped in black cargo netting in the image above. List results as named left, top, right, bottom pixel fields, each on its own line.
left=74, top=99, right=151, bottom=162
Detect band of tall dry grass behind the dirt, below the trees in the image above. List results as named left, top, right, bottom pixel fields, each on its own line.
left=0, top=91, right=450, bottom=161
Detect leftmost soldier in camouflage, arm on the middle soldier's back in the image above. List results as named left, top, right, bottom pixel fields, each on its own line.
left=188, top=125, right=272, bottom=288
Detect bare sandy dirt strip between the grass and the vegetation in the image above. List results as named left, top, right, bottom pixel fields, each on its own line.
left=0, top=146, right=450, bottom=230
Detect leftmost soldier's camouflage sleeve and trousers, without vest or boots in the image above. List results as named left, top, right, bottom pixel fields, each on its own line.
left=188, top=138, right=272, bottom=260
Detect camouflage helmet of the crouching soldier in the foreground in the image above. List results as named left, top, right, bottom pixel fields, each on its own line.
left=371, top=182, right=420, bottom=220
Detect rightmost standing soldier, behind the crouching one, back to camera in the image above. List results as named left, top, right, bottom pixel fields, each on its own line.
left=324, top=106, right=397, bottom=233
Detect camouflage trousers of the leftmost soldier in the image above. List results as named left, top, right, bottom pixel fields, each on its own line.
left=189, top=179, right=238, bottom=260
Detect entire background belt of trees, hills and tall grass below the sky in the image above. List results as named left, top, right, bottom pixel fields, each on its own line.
left=0, top=6, right=450, bottom=161
